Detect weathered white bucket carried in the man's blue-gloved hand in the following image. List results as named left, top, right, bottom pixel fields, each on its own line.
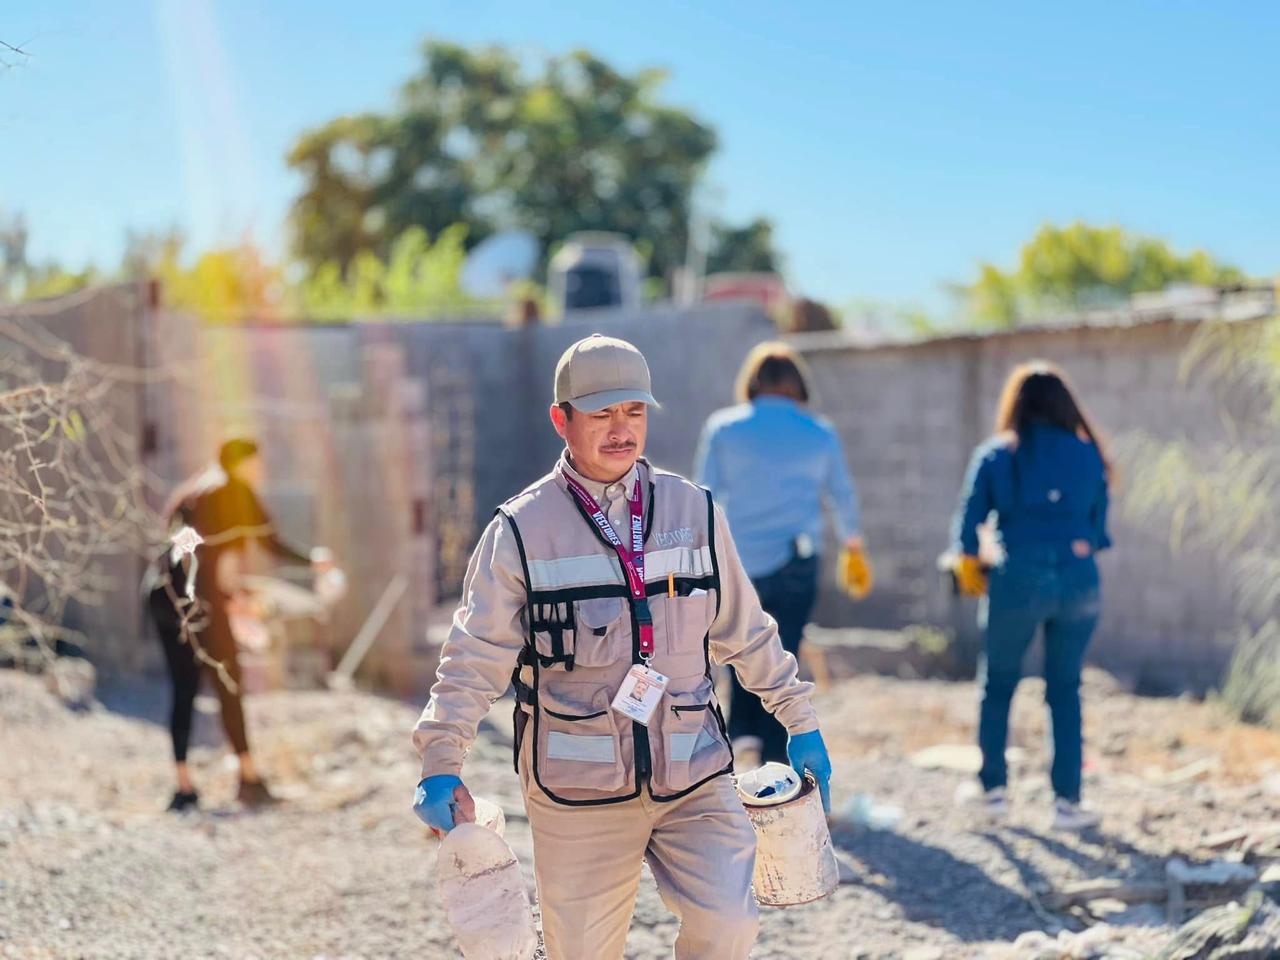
left=739, top=764, right=840, bottom=906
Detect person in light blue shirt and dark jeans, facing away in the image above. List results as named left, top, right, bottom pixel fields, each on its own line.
left=694, top=343, right=863, bottom=763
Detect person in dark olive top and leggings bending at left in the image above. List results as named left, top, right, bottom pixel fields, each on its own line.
left=147, top=439, right=332, bottom=810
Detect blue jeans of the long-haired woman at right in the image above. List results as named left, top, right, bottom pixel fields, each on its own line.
left=978, top=549, right=1101, bottom=803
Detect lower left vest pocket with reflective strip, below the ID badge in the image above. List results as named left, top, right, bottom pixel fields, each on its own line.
left=535, top=684, right=626, bottom=792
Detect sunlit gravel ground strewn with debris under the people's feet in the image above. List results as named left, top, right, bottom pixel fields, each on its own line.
left=0, top=672, right=1280, bottom=960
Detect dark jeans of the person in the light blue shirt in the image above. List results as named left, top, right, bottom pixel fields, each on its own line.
left=728, top=557, right=819, bottom=763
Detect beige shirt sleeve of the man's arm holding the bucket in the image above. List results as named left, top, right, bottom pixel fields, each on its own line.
left=710, top=506, right=818, bottom=733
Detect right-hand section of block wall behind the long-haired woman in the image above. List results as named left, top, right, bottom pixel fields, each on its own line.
left=797, top=321, right=1261, bottom=691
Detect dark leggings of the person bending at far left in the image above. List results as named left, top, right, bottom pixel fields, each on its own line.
left=147, top=588, right=248, bottom=763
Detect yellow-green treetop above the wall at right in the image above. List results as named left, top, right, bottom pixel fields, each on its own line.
left=964, top=223, right=1245, bottom=328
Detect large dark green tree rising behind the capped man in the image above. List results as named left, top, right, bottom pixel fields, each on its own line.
left=288, top=41, right=776, bottom=288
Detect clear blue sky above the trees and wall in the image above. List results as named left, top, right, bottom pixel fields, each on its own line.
left=0, top=0, right=1280, bottom=312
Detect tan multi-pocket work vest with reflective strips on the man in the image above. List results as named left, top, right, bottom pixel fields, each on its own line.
left=499, top=461, right=733, bottom=806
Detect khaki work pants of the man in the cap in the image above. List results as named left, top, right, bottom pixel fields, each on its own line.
left=522, top=776, right=759, bottom=960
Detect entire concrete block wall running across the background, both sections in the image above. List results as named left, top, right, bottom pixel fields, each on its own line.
left=15, top=288, right=1275, bottom=690
